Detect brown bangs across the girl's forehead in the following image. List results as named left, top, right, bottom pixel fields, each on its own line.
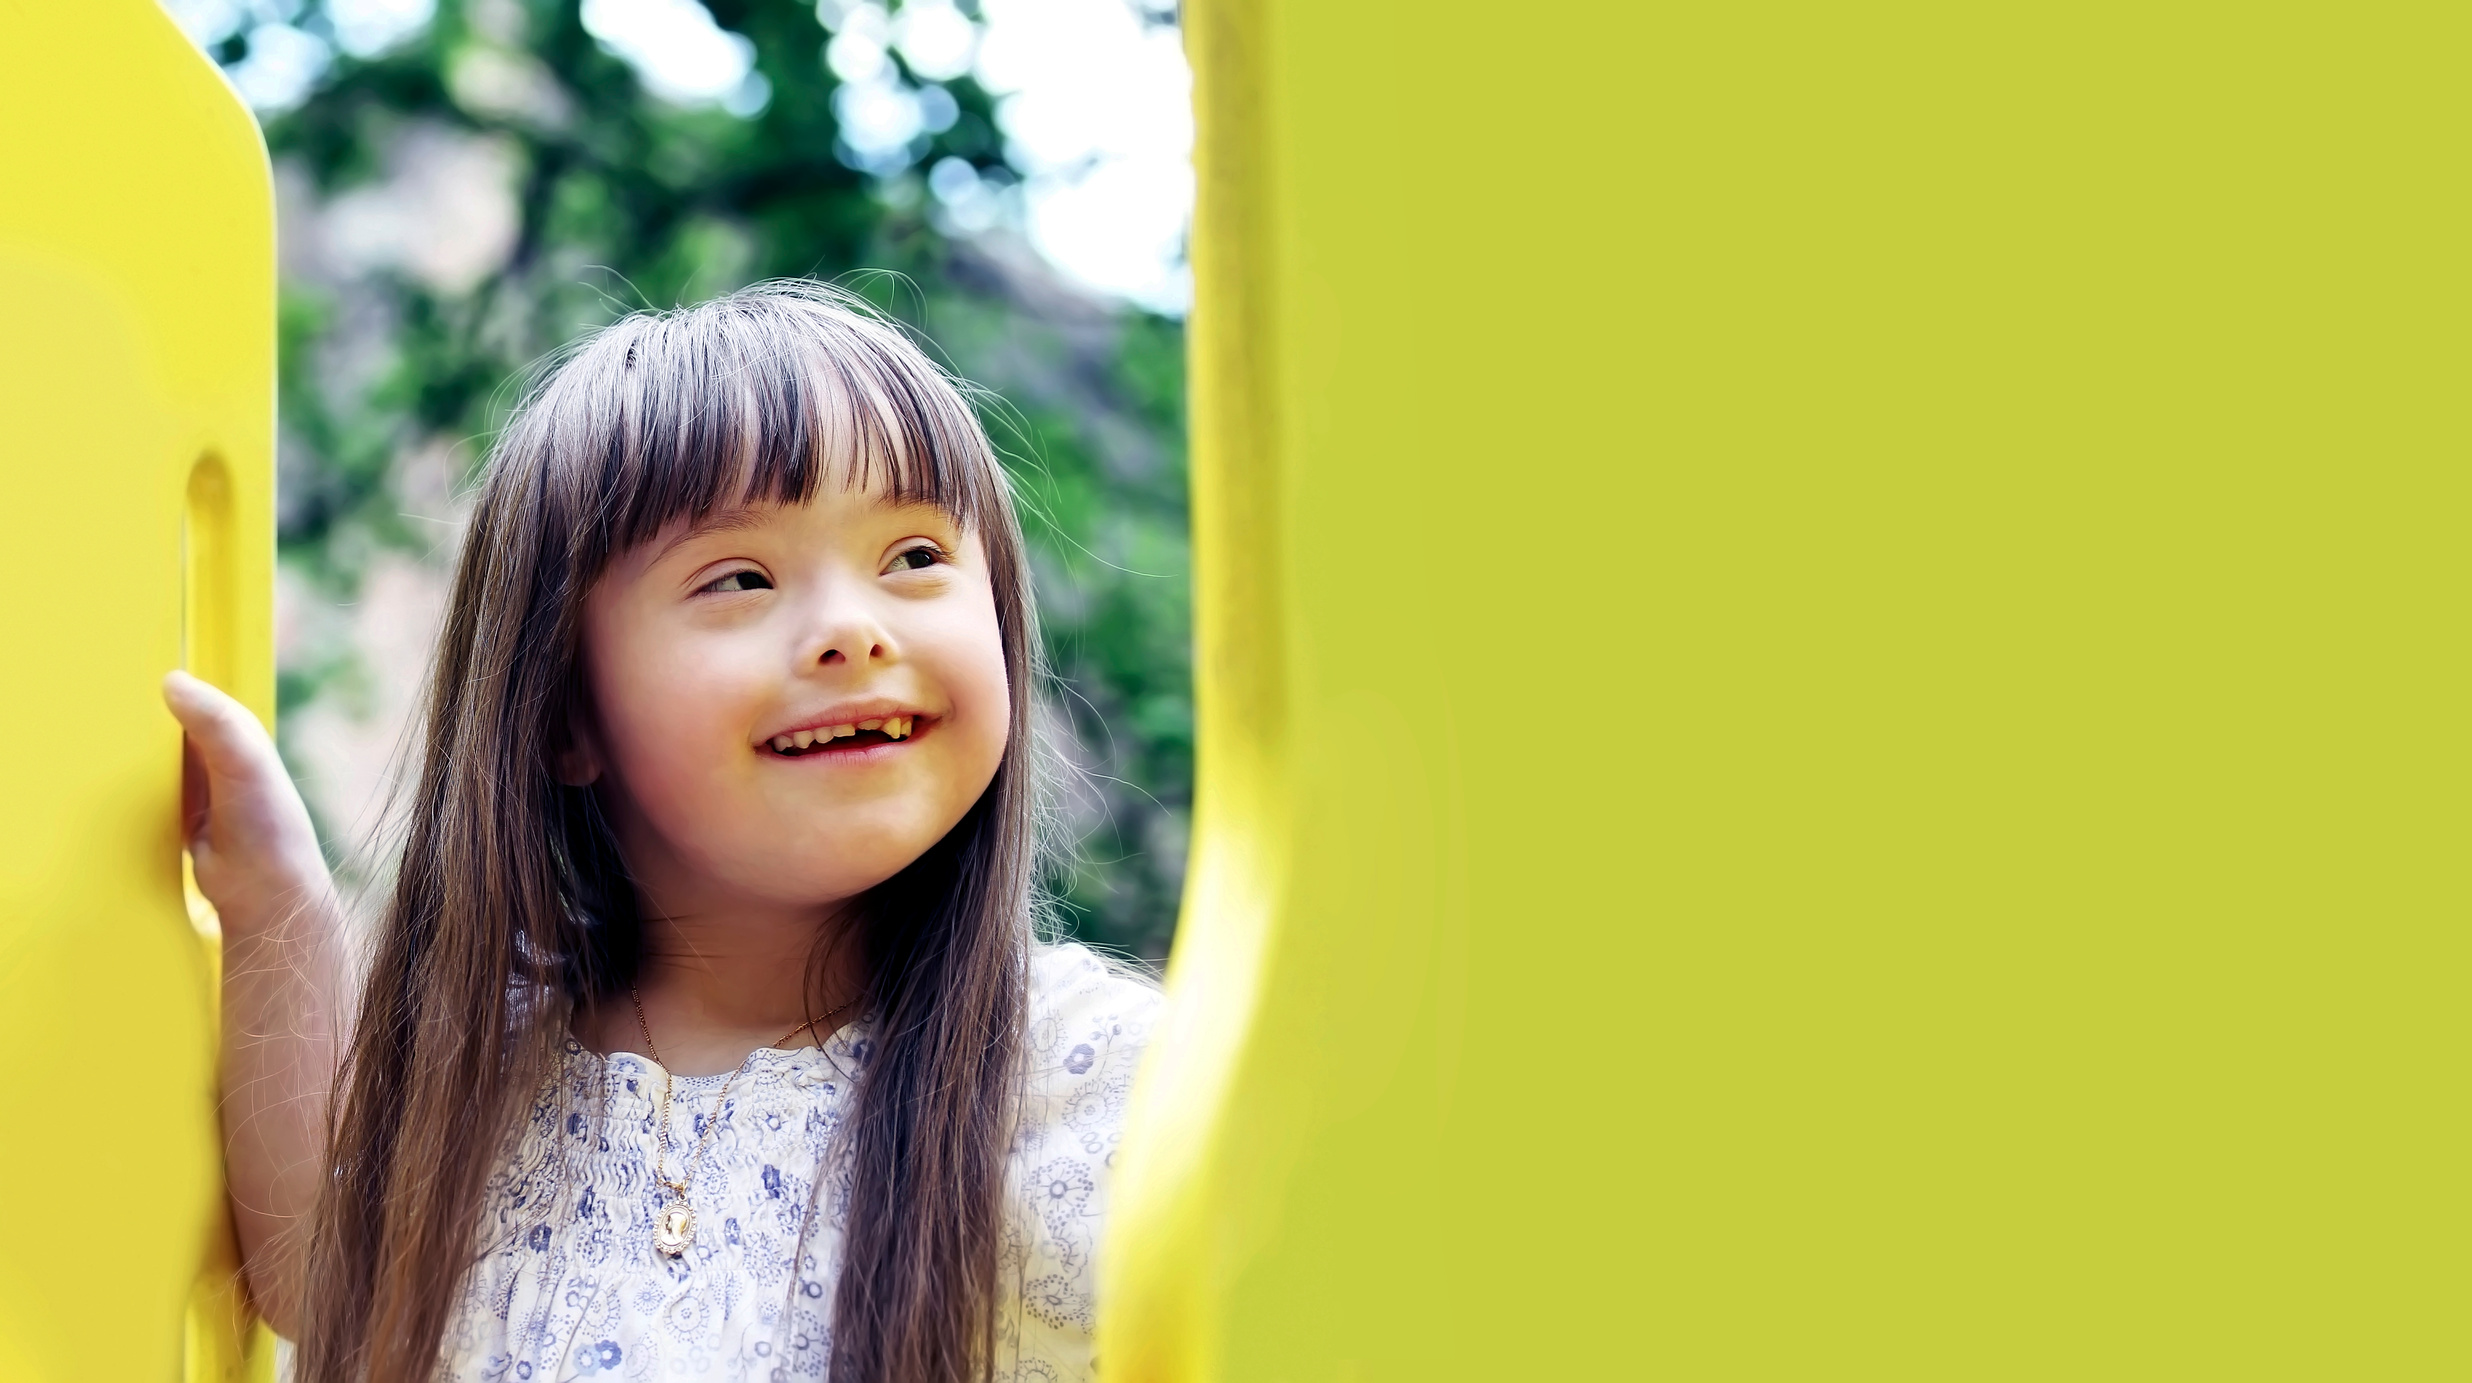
left=531, top=285, right=1009, bottom=559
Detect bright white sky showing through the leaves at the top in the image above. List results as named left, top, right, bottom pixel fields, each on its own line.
left=166, top=0, right=1194, bottom=314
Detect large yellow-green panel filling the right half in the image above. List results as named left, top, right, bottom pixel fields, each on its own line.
left=1100, top=0, right=2472, bottom=1383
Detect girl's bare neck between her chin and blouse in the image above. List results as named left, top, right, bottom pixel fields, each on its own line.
left=576, top=908, right=865, bottom=1076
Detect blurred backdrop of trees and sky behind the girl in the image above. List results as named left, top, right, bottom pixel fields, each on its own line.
left=166, top=0, right=1192, bottom=957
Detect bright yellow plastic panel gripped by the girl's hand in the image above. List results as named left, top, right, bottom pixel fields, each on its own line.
left=0, top=0, right=274, bottom=1383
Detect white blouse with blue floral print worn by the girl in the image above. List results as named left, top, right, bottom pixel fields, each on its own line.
left=440, top=945, right=1159, bottom=1383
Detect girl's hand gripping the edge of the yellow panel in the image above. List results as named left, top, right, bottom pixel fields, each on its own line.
left=163, top=673, right=334, bottom=938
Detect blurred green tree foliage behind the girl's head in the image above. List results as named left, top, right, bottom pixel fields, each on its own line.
left=260, top=0, right=1192, bottom=955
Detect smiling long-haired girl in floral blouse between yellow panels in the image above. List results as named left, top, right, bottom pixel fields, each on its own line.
left=168, top=287, right=1157, bottom=1383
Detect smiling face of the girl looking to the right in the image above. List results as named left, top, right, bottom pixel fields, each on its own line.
left=559, top=485, right=1011, bottom=915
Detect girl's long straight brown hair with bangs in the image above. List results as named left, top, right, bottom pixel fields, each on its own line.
left=297, top=285, right=1038, bottom=1383
